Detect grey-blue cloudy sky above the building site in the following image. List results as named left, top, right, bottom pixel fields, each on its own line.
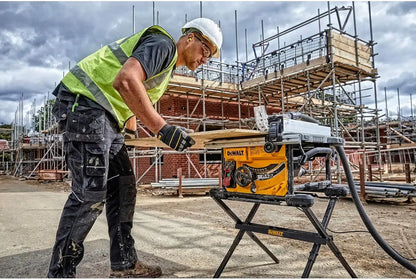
left=0, top=1, right=416, bottom=124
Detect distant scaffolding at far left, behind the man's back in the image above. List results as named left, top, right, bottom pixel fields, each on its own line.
left=3, top=96, right=68, bottom=180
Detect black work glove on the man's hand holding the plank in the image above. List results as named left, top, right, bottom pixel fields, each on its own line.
left=157, top=124, right=195, bottom=151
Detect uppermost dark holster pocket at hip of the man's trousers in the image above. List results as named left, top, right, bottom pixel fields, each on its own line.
left=64, top=105, right=105, bottom=142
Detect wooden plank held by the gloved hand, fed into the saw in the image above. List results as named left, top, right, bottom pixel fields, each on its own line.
left=126, top=129, right=266, bottom=149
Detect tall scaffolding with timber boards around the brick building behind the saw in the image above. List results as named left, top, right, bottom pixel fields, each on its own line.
left=132, top=3, right=381, bottom=186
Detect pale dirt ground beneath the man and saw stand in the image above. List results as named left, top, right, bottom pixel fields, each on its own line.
left=0, top=175, right=416, bottom=278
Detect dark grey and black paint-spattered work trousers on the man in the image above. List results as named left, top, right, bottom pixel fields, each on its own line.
left=48, top=98, right=137, bottom=277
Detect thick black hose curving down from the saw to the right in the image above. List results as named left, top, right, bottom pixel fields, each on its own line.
left=336, top=146, right=416, bottom=273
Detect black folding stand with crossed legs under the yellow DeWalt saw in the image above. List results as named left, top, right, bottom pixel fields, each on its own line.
left=210, top=188, right=357, bottom=278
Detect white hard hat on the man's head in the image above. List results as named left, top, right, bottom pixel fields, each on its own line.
left=182, top=17, right=222, bottom=58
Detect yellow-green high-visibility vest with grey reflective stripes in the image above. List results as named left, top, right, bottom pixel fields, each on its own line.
left=62, top=26, right=178, bottom=128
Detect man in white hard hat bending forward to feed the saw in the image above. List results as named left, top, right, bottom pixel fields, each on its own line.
left=48, top=18, right=222, bottom=277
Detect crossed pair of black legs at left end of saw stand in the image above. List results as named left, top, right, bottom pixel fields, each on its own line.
left=214, top=197, right=279, bottom=278
